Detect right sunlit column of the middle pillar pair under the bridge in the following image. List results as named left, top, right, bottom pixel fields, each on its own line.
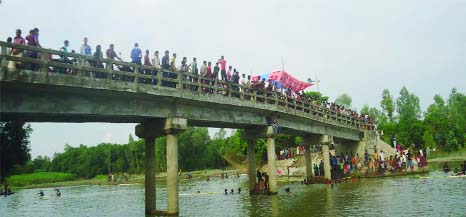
left=267, top=126, right=278, bottom=194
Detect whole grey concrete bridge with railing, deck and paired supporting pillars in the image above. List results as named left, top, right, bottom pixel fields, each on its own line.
left=0, top=41, right=367, bottom=215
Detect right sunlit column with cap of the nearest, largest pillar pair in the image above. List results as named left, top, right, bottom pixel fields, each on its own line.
left=164, top=118, right=187, bottom=215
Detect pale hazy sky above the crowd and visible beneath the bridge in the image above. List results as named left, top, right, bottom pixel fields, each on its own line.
left=0, top=0, right=466, bottom=157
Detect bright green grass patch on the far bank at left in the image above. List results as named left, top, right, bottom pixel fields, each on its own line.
left=7, top=172, right=76, bottom=187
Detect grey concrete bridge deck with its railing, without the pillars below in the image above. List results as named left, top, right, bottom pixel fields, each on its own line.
left=0, top=42, right=366, bottom=140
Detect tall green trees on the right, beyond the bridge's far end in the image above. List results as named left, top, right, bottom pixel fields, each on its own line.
left=378, top=87, right=466, bottom=152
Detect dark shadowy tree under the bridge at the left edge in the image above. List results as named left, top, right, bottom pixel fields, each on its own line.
left=0, top=122, right=32, bottom=183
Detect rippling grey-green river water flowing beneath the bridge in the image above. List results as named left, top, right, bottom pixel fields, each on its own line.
left=0, top=171, right=466, bottom=217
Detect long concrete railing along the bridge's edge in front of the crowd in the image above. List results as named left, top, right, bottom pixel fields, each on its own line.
left=0, top=41, right=371, bottom=129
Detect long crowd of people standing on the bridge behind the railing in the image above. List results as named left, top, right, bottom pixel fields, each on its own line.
left=3, top=28, right=375, bottom=129
